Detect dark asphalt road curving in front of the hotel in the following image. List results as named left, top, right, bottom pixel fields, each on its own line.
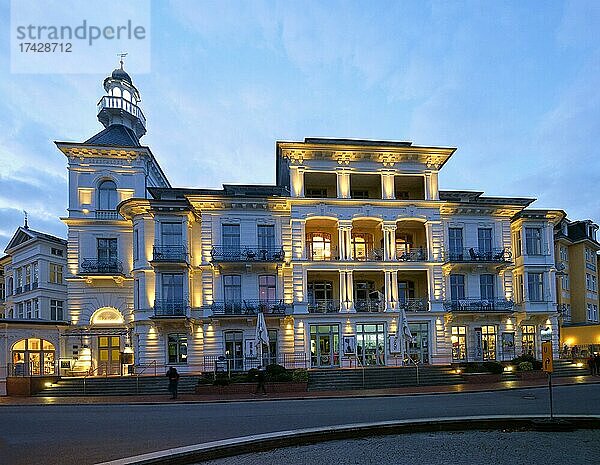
left=0, top=384, right=600, bottom=465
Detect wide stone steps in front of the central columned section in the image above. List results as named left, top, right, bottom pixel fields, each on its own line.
left=308, top=366, right=464, bottom=391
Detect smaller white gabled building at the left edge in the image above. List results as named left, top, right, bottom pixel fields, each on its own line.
left=0, top=223, right=69, bottom=393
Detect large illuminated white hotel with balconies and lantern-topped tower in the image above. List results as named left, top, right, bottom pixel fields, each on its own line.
left=50, top=67, right=564, bottom=374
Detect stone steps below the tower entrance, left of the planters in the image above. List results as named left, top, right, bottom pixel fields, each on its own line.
left=36, top=375, right=199, bottom=397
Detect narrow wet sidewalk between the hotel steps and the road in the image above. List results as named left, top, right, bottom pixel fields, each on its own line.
left=0, top=375, right=600, bottom=406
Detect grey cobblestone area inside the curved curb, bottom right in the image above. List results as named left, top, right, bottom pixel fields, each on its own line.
left=204, top=430, right=600, bottom=465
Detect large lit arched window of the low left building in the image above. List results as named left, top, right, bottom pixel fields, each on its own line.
left=12, top=338, right=56, bottom=376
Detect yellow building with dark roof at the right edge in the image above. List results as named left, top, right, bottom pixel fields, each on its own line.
left=554, top=218, right=600, bottom=347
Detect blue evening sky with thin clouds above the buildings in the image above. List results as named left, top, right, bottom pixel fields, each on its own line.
left=0, top=0, right=600, bottom=250
